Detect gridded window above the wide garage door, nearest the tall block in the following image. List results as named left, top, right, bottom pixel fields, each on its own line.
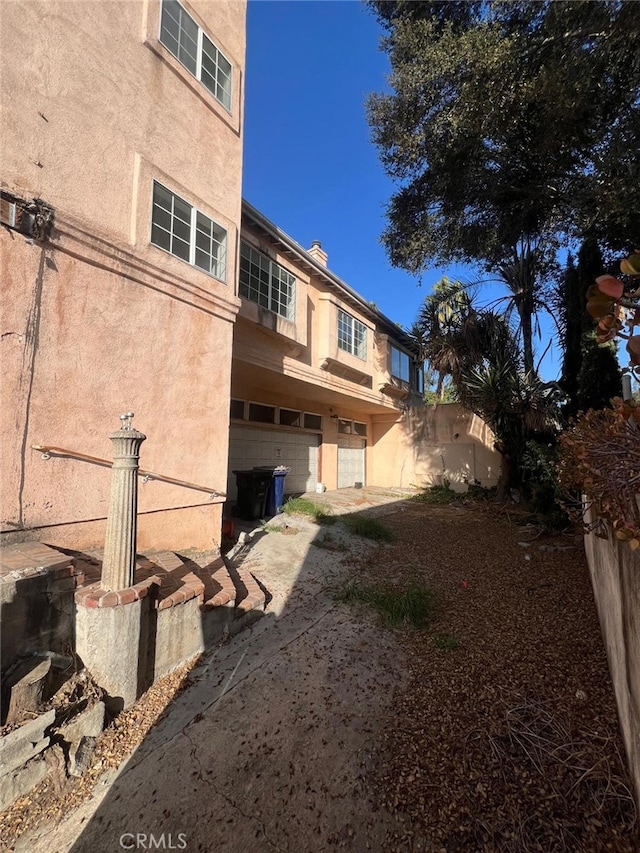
left=239, top=242, right=296, bottom=320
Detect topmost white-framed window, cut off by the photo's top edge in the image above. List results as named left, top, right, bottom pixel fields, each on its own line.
left=160, top=0, right=231, bottom=112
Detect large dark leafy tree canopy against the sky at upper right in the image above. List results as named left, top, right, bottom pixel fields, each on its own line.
left=368, top=0, right=640, bottom=273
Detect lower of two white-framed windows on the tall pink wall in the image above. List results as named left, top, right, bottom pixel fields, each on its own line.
left=151, top=181, right=227, bottom=281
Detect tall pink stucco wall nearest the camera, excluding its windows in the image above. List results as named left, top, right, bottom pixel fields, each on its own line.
left=0, top=0, right=246, bottom=549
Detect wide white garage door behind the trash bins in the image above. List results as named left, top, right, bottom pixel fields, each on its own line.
left=227, top=425, right=319, bottom=498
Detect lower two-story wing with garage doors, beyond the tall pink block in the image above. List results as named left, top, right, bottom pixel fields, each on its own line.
left=227, top=202, right=423, bottom=497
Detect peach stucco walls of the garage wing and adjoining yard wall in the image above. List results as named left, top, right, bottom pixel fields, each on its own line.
left=232, top=211, right=500, bottom=490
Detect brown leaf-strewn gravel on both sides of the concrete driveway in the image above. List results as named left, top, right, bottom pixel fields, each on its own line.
left=0, top=496, right=640, bottom=853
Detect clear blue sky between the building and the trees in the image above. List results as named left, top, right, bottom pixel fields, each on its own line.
left=243, top=0, right=557, bottom=379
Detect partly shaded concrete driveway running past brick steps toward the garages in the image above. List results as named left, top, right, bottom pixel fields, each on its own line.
left=15, top=489, right=416, bottom=853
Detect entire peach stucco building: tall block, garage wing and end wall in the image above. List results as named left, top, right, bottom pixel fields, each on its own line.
left=0, top=0, right=498, bottom=550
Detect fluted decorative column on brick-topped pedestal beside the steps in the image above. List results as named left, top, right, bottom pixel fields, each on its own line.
left=100, top=412, right=146, bottom=591
